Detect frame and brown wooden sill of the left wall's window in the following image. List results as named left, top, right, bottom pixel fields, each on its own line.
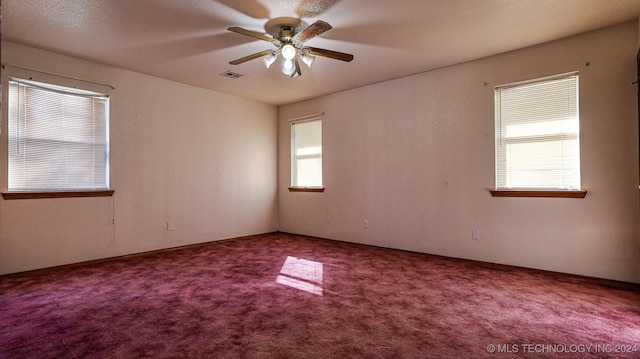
left=2, top=77, right=115, bottom=200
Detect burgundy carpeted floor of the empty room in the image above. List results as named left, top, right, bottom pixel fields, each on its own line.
left=0, top=233, right=640, bottom=358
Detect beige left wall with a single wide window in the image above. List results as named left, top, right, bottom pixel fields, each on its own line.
left=0, top=42, right=277, bottom=274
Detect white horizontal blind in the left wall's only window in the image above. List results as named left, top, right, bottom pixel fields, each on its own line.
left=8, top=79, right=109, bottom=192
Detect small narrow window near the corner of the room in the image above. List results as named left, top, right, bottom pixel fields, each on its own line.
left=291, top=116, right=322, bottom=190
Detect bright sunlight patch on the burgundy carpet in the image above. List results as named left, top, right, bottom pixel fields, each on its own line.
left=276, top=256, right=322, bottom=295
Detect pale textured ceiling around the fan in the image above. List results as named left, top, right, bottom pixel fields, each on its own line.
left=1, top=0, right=640, bottom=105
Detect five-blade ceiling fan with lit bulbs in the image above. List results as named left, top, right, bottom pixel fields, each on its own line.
left=227, top=17, right=353, bottom=77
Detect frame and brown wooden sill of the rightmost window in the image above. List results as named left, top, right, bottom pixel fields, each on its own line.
left=489, top=71, right=587, bottom=198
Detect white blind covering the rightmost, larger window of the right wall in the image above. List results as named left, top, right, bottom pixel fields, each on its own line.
left=495, top=73, right=581, bottom=190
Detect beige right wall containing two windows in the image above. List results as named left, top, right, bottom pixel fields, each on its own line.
left=278, top=22, right=640, bottom=282
